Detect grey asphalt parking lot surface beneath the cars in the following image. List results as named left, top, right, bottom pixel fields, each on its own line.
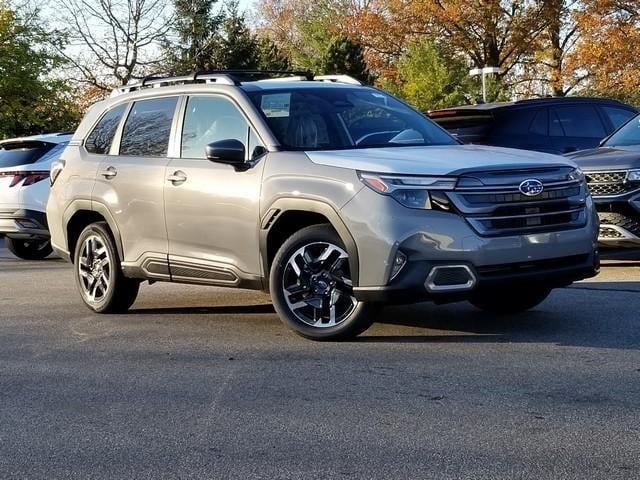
left=0, top=238, right=640, bottom=479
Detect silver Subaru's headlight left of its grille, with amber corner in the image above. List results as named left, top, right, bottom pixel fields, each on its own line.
left=359, top=173, right=456, bottom=209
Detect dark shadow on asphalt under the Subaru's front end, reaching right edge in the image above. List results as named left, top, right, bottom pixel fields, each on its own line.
left=355, top=282, right=640, bottom=350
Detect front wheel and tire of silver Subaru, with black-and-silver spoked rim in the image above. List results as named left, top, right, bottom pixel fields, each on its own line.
left=269, top=224, right=375, bottom=340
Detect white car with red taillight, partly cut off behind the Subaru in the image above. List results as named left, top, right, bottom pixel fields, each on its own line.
left=0, top=133, right=72, bottom=260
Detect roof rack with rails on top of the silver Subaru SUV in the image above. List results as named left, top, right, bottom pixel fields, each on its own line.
left=111, top=70, right=363, bottom=97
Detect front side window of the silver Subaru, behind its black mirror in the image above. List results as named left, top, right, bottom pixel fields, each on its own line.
left=182, top=97, right=249, bottom=158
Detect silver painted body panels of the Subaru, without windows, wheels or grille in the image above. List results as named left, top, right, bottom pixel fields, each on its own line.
left=47, top=82, right=598, bottom=304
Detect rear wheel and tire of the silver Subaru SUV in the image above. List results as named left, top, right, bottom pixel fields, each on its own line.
left=73, top=222, right=140, bottom=313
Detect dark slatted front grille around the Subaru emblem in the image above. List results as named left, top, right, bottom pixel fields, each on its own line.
left=449, top=167, right=587, bottom=236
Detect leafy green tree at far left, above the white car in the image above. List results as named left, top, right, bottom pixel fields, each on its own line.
left=0, top=0, right=80, bottom=138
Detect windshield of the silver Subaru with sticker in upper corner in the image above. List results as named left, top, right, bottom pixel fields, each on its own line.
left=248, top=87, right=458, bottom=150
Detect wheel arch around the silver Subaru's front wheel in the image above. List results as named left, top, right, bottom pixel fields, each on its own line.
left=260, top=198, right=359, bottom=290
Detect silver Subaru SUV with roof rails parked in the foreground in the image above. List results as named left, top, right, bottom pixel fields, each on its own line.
left=47, top=72, right=598, bottom=340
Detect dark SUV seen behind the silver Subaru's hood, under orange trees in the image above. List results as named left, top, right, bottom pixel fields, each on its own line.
left=428, top=97, right=638, bottom=154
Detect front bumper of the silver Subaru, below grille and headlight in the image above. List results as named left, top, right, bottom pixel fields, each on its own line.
left=341, top=185, right=599, bottom=303
